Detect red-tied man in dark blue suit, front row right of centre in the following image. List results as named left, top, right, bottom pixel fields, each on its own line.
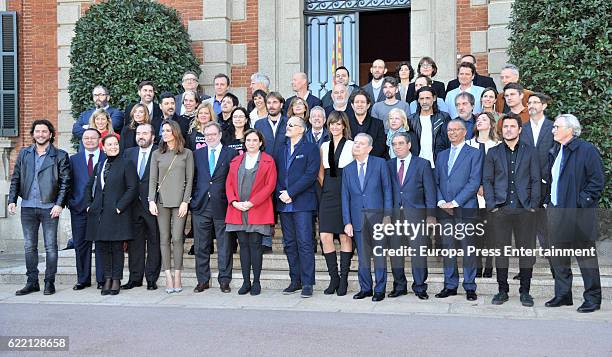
left=387, top=133, right=436, bottom=300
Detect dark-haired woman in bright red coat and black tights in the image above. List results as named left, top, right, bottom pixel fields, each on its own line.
left=225, top=130, right=276, bottom=295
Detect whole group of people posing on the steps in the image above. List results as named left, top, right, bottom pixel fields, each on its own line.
left=9, top=55, right=605, bottom=312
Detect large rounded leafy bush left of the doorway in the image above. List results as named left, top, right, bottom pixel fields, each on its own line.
left=68, top=0, right=201, bottom=118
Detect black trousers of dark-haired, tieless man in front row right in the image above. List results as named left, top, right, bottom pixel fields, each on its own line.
left=490, top=207, right=535, bottom=293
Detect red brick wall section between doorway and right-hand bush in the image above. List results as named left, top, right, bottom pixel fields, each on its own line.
left=457, top=0, right=489, bottom=74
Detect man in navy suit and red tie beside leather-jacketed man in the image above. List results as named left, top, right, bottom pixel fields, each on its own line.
left=68, top=128, right=106, bottom=290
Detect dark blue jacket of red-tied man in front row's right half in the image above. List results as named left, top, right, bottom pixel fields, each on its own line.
left=387, top=155, right=437, bottom=214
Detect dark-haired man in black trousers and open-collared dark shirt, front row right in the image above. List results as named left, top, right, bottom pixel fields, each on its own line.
left=482, top=114, right=542, bottom=307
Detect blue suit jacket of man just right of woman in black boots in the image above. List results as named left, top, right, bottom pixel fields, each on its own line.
left=342, top=155, right=393, bottom=231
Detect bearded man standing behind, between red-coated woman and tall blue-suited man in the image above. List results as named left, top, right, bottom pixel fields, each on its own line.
left=255, top=92, right=287, bottom=253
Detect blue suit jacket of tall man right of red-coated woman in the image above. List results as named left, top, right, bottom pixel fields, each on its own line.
left=274, top=138, right=321, bottom=212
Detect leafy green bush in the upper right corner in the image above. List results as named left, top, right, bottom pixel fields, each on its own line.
left=508, top=0, right=612, bottom=208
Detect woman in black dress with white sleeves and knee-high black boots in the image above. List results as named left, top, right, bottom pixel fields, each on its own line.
left=319, top=111, right=353, bottom=296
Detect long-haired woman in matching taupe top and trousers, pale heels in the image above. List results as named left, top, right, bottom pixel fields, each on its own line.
left=149, top=121, right=193, bottom=294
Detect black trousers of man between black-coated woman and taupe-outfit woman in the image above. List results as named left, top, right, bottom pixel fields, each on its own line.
left=128, top=207, right=161, bottom=282
